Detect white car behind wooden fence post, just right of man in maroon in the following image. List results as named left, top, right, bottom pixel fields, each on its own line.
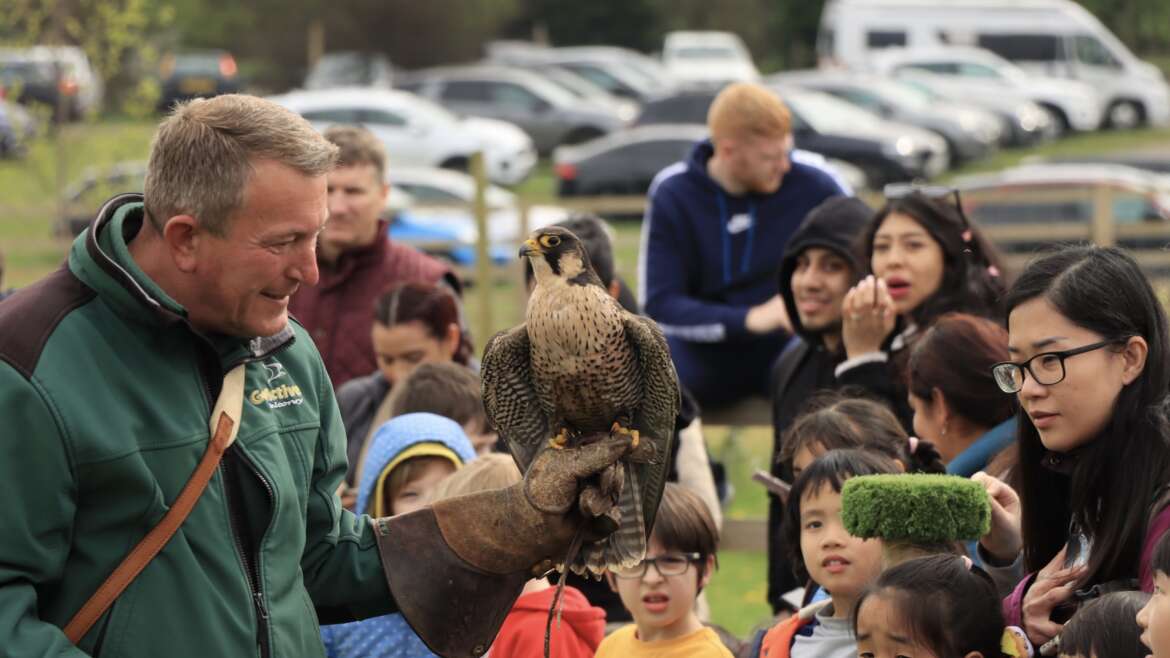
left=386, top=167, right=569, bottom=244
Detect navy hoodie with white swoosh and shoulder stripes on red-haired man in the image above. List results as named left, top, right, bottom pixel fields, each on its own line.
left=638, top=139, right=851, bottom=343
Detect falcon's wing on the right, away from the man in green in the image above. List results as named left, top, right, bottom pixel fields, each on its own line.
left=624, top=314, right=680, bottom=536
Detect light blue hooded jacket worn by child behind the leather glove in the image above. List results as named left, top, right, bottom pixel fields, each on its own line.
left=321, top=413, right=475, bottom=658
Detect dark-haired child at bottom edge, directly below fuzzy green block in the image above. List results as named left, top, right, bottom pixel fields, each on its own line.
left=853, top=555, right=1024, bottom=658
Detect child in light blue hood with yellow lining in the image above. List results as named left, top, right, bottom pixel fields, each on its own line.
left=321, top=413, right=475, bottom=658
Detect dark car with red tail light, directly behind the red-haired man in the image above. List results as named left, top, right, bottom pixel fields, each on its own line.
left=552, top=123, right=867, bottom=197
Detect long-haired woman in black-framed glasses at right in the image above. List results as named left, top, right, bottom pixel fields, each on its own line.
left=980, top=242, right=1170, bottom=646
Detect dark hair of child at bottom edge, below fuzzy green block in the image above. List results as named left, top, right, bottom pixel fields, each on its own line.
left=853, top=555, right=1004, bottom=658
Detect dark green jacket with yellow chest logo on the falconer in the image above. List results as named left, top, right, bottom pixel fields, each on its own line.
left=0, top=194, right=395, bottom=658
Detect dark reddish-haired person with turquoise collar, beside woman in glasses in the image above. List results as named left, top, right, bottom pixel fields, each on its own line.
left=907, top=313, right=1016, bottom=478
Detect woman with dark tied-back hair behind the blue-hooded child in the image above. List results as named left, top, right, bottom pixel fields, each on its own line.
left=337, top=282, right=473, bottom=503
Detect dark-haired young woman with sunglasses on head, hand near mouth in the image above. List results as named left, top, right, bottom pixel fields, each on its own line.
left=835, top=187, right=1004, bottom=431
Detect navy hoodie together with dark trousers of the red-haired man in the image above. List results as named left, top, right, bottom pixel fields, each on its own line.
left=638, top=139, right=851, bottom=405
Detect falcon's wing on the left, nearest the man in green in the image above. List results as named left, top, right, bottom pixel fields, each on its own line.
left=480, top=324, right=551, bottom=473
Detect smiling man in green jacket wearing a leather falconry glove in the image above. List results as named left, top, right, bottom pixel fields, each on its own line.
left=0, top=95, right=628, bottom=658
